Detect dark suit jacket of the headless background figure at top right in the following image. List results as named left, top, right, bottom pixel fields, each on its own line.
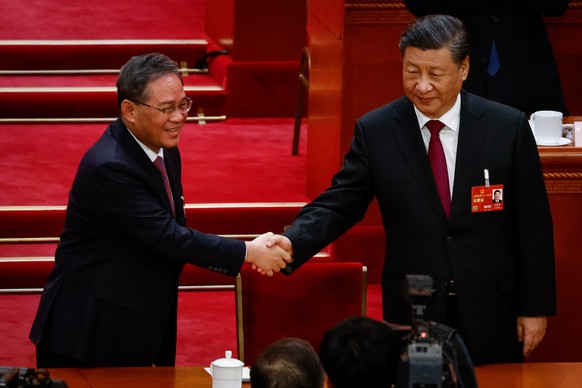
left=404, top=0, right=568, bottom=115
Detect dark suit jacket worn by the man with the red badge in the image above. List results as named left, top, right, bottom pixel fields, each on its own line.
left=283, top=91, right=556, bottom=363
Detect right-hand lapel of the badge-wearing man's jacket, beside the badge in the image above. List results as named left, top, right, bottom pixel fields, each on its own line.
left=450, top=92, right=487, bottom=219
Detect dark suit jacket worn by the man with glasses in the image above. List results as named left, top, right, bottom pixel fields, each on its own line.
left=30, top=119, right=245, bottom=366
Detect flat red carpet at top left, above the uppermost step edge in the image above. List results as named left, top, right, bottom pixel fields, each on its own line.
left=0, top=0, right=205, bottom=39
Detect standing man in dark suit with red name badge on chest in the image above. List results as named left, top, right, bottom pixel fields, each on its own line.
left=270, top=15, right=556, bottom=364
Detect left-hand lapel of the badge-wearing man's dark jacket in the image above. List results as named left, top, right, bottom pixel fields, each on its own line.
left=393, top=99, right=447, bottom=223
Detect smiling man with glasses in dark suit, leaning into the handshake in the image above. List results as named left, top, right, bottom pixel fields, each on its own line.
left=30, top=53, right=290, bottom=368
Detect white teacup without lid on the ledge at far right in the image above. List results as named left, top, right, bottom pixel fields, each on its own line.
left=529, top=110, right=572, bottom=146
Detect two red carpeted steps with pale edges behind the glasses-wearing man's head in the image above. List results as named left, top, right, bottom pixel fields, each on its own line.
left=0, top=39, right=226, bottom=122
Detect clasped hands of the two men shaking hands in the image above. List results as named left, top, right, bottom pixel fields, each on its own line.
left=245, top=232, right=293, bottom=276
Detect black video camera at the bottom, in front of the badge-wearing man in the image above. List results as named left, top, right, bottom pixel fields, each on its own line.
left=396, top=275, right=477, bottom=388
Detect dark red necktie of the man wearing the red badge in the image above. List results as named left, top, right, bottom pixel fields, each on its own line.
left=426, top=120, right=451, bottom=218
